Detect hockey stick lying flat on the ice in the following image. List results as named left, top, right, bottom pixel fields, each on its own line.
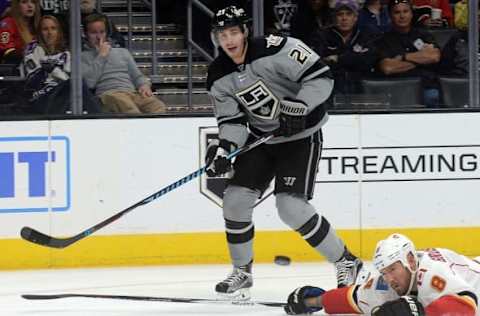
left=22, top=293, right=286, bottom=307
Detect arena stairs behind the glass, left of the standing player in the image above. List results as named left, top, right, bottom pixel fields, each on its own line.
left=102, top=0, right=212, bottom=112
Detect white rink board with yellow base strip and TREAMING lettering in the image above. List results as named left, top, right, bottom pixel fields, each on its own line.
left=0, top=113, right=480, bottom=269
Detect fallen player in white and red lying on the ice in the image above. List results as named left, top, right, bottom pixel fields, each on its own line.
left=285, top=234, right=480, bottom=316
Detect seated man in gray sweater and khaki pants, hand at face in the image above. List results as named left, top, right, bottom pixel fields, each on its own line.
left=82, top=14, right=166, bottom=113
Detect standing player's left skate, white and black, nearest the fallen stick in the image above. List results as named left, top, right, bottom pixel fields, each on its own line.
left=215, top=265, right=253, bottom=301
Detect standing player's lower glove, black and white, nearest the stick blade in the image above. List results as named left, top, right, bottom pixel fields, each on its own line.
left=205, top=139, right=237, bottom=177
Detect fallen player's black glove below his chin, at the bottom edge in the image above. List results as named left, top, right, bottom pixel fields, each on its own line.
left=372, top=296, right=425, bottom=316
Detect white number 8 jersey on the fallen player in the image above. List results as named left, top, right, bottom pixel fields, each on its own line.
left=356, top=248, right=480, bottom=316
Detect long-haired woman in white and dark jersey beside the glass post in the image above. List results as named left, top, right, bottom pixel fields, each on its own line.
left=23, top=15, right=100, bottom=114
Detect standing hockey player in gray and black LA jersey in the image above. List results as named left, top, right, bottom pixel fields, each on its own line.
left=205, top=6, right=362, bottom=299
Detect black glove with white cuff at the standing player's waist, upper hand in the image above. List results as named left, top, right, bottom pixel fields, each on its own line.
left=275, top=99, right=308, bottom=137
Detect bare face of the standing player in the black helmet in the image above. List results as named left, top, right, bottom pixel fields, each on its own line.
left=217, top=26, right=246, bottom=64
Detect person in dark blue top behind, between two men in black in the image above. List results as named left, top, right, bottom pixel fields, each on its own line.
left=358, top=0, right=392, bottom=34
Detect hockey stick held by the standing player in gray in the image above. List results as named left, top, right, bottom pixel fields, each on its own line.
left=20, top=134, right=273, bottom=248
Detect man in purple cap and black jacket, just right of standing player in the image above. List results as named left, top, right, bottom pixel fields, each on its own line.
left=310, top=0, right=376, bottom=93
